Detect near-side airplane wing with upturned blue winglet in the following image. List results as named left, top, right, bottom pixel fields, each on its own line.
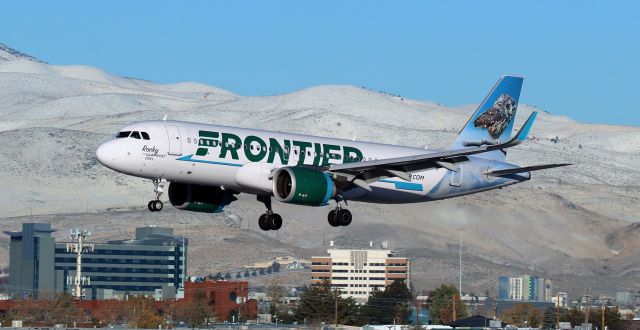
left=327, top=112, right=537, bottom=191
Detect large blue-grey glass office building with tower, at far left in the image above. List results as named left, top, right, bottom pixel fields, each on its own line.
left=5, top=223, right=188, bottom=299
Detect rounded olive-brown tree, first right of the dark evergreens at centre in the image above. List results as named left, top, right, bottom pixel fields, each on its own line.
left=429, top=284, right=468, bottom=324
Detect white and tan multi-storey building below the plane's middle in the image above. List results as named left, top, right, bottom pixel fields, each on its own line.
left=311, top=245, right=411, bottom=301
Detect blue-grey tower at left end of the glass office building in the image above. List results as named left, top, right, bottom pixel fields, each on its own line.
left=4, top=223, right=55, bottom=299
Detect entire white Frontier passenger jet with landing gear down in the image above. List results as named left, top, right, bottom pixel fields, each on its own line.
left=96, top=76, right=568, bottom=230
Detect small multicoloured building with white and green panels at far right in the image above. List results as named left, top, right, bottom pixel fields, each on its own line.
left=498, top=275, right=552, bottom=302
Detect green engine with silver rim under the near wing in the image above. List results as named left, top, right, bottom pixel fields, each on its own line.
left=273, top=166, right=336, bottom=206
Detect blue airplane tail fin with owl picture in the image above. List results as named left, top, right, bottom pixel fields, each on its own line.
left=451, top=76, right=524, bottom=160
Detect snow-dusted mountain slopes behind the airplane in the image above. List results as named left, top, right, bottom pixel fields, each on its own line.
left=0, top=44, right=640, bottom=290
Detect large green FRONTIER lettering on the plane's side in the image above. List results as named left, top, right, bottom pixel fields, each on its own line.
left=195, top=131, right=363, bottom=166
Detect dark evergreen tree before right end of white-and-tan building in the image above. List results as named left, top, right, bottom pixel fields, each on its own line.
left=364, top=280, right=411, bottom=324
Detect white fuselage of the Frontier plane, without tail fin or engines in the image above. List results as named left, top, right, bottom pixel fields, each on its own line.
left=96, top=121, right=528, bottom=203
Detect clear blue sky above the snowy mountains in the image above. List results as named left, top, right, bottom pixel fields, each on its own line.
left=0, top=0, right=640, bottom=126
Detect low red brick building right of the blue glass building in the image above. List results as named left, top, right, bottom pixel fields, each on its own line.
left=184, top=280, right=258, bottom=322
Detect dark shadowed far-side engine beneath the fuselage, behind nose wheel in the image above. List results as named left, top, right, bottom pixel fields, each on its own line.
left=169, top=182, right=237, bottom=213
